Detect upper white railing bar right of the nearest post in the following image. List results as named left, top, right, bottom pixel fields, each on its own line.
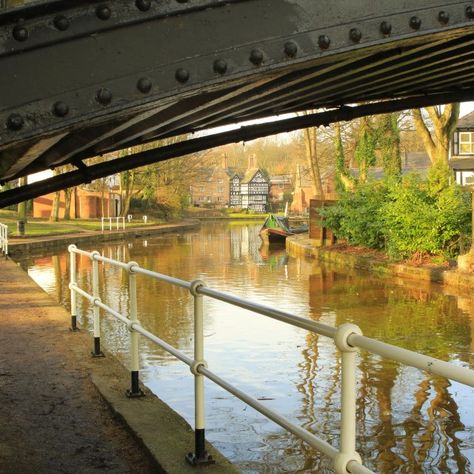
left=348, top=334, right=474, bottom=387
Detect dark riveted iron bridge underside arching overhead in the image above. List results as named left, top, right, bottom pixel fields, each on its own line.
left=0, top=0, right=474, bottom=207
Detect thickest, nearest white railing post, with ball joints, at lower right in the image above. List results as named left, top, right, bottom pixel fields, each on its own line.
left=334, top=324, right=362, bottom=474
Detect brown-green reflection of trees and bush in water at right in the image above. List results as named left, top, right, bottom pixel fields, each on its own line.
left=297, top=269, right=471, bottom=473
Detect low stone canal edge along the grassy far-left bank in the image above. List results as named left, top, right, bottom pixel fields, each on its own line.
left=8, top=219, right=201, bottom=258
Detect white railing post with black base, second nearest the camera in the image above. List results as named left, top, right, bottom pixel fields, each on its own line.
left=186, top=280, right=215, bottom=466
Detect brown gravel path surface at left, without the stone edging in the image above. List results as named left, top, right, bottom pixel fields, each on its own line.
left=0, top=258, right=157, bottom=474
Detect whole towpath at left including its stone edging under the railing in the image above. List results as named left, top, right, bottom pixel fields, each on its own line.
left=0, top=241, right=239, bottom=474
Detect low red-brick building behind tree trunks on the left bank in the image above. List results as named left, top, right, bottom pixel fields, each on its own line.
left=33, top=188, right=120, bottom=219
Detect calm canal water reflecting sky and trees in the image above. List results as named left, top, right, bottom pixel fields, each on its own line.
left=16, top=223, right=474, bottom=474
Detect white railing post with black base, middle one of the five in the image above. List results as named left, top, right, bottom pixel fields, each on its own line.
left=125, top=262, right=145, bottom=398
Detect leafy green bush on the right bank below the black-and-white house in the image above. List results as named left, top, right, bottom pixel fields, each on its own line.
left=321, top=169, right=471, bottom=258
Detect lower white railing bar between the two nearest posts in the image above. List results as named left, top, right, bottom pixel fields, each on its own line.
left=198, top=366, right=338, bottom=459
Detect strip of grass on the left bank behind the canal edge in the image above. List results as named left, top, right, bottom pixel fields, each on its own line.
left=0, top=209, right=164, bottom=237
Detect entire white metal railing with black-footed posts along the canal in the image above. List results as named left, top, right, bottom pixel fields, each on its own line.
left=69, top=245, right=474, bottom=474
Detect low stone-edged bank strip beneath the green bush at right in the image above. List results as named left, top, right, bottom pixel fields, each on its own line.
left=286, top=234, right=474, bottom=294
